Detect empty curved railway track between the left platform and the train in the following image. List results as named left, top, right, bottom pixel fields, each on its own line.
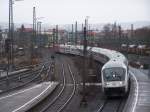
left=37, top=64, right=76, bottom=112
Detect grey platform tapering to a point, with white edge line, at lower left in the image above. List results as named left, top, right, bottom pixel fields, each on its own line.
left=0, top=82, right=58, bottom=112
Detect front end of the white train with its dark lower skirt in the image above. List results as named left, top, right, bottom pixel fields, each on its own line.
left=101, top=61, right=129, bottom=96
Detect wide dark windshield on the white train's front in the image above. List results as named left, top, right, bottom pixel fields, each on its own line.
left=103, top=67, right=125, bottom=81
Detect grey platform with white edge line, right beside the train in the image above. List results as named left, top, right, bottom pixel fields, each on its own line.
left=124, top=67, right=150, bottom=112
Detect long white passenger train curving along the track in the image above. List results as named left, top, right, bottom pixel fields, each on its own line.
left=57, top=45, right=130, bottom=96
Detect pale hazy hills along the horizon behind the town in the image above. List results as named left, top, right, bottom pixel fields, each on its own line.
left=0, top=21, right=150, bottom=31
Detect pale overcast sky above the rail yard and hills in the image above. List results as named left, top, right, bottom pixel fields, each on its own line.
left=0, top=0, right=150, bottom=24
